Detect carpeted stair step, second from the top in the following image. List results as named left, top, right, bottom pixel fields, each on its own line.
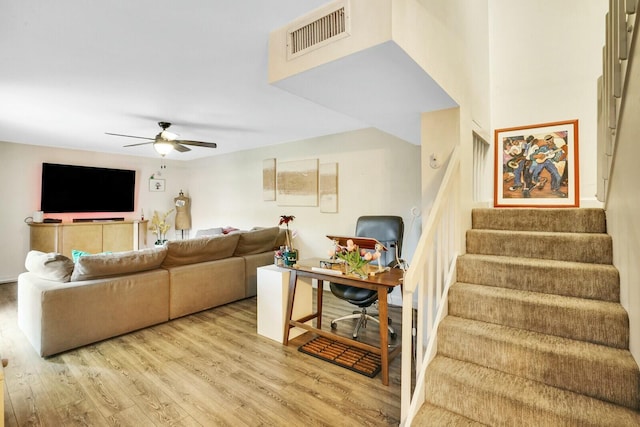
left=467, top=230, right=613, bottom=264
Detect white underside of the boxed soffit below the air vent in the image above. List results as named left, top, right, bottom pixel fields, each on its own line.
left=275, top=41, right=456, bottom=145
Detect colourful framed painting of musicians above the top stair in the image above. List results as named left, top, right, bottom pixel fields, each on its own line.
left=493, top=120, right=580, bottom=208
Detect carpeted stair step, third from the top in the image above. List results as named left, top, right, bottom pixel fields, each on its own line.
left=456, top=254, right=620, bottom=302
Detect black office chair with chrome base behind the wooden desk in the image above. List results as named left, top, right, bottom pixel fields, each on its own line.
left=329, top=215, right=404, bottom=339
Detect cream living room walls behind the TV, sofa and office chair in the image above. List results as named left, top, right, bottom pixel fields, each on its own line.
left=0, top=129, right=420, bottom=290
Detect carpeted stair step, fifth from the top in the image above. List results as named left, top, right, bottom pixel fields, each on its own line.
left=438, top=316, right=640, bottom=410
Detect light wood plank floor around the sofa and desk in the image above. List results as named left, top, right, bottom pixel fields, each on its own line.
left=0, top=283, right=401, bottom=426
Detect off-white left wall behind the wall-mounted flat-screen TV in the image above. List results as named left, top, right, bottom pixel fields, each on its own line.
left=0, top=141, right=188, bottom=283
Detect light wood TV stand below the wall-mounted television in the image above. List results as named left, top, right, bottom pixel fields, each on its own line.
left=29, top=220, right=149, bottom=257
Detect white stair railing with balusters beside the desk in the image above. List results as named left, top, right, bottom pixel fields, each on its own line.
left=400, top=146, right=461, bottom=425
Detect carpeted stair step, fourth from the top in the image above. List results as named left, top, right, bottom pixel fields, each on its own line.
left=449, top=282, right=629, bottom=349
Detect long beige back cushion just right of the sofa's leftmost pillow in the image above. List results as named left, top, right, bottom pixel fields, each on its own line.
left=71, top=247, right=167, bottom=281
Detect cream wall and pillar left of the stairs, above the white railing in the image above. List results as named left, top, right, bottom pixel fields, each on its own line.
left=393, top=0, right=491, bottom=234
